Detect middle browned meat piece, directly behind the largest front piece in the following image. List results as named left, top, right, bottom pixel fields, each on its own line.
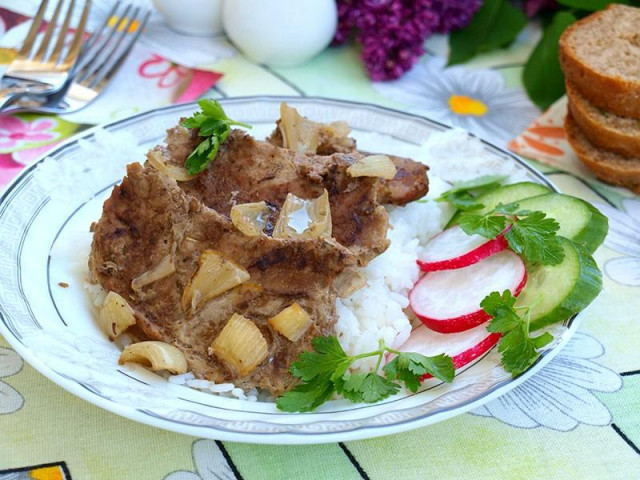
left=179, top=129, right=389, bottom=264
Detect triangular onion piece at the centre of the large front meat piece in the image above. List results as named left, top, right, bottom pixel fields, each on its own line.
left=182, top=250, right=249, bottom=313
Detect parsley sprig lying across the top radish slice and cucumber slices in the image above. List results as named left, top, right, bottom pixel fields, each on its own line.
left=458, top=203, right=564, bottom=265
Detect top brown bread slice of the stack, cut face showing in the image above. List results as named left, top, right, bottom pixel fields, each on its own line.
left=560, top=4, right=640, bottom=118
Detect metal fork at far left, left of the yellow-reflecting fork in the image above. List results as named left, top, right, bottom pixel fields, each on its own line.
left=0, top=0, right=91, bottom=109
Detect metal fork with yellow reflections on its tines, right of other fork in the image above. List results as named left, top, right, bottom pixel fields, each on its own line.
left=2, top=2, right=151, bottom=114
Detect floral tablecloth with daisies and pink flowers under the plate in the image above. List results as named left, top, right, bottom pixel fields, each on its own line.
left=0, top=0, right=640, bottom=480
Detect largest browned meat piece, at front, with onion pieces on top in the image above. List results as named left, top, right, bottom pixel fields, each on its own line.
left=89, top=164, right=355, bottom=395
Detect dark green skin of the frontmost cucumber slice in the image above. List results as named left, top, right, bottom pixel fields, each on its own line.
left=529, top=240, right=602, bottom=330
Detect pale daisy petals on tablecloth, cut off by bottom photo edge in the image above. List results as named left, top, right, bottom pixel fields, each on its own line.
left=164, top=439, right=237, bottom=480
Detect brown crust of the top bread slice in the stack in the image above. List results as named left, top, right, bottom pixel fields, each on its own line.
left=559, top=5, right=640, bottom=118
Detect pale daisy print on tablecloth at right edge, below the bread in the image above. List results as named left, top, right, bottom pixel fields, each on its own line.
left=593, top=198, right=640, bottom=287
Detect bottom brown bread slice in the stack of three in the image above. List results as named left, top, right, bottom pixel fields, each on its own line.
left=564, top=114, right=640, bottom=193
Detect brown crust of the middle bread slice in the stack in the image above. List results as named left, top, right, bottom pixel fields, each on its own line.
left=567, top=82, right=640, bottom=157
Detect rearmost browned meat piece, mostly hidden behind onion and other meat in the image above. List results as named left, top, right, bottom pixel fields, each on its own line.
left=267, top=120, right=429, bottom=205
